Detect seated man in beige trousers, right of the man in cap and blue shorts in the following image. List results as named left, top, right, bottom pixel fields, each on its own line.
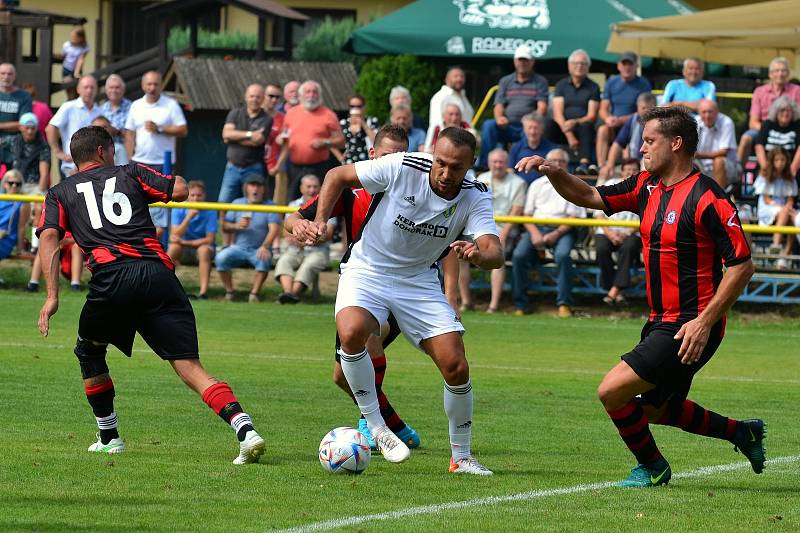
left=275, top=174, right=336, bottom=304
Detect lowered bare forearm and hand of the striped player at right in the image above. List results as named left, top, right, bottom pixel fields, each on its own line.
left=675, top=259, right=756, bottom=365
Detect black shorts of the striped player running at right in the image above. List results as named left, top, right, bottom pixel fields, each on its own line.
left=622, top=320, right=725, bottom=407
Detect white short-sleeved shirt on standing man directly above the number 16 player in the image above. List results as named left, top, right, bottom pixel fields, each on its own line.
left=125, top=94, right=186, bottom=165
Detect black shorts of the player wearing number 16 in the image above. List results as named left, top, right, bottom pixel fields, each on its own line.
left=78, top=261, right=199, bottom=359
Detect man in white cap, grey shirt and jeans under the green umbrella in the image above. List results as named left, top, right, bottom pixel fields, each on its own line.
left=478, top=45, right=548, bottom=167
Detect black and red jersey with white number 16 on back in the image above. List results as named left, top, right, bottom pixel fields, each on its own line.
left=37, top=163, right=175, bottom=271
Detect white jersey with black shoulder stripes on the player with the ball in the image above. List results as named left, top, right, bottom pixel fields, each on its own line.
left=342, top=152, right=497, bottom=276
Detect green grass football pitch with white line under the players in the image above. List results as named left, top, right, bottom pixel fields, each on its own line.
left=0, top=289, right=800, bottom=532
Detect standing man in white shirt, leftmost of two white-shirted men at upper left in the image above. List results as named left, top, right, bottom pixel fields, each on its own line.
left=45, top=76, right=102, bottom=177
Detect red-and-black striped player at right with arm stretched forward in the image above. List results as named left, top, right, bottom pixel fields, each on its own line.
left=517, top=107, right=765, bottom=487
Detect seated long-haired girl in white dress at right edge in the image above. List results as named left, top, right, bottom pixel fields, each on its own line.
left=753, top=146, right=797, bottom=270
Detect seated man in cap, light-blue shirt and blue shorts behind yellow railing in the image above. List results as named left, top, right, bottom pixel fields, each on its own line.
left=215, top=174, right=281, bottom=303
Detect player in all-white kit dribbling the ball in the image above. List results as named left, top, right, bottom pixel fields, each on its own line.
left=305, top=128, right=503, bottom=475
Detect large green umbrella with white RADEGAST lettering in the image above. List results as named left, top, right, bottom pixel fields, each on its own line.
left=345, top=0, right=694, bottom=61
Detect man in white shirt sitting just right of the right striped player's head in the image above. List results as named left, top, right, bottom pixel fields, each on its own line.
left=694, top=100, right=739, bottom=189
